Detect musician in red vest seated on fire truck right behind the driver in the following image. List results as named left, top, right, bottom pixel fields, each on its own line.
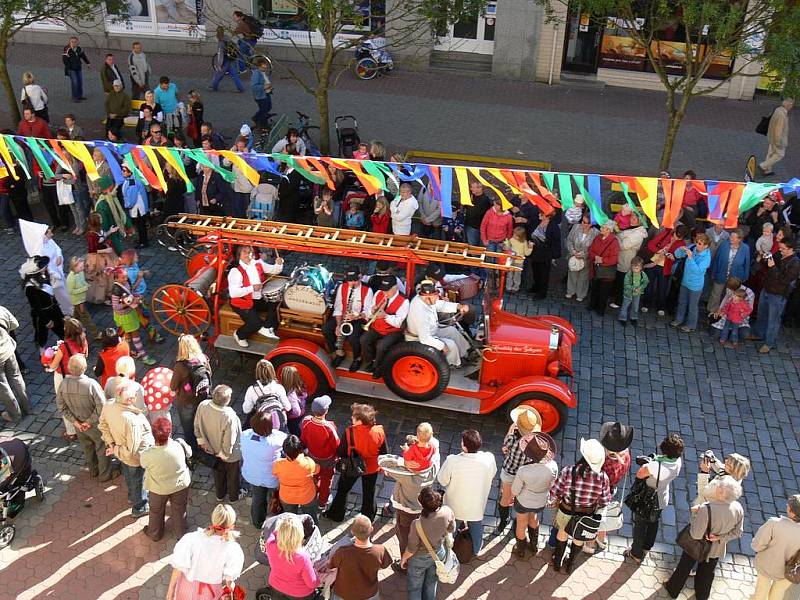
left=361, top=275, right=408, bottom=379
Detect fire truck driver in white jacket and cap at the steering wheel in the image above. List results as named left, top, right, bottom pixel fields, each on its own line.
left=406, top=279, right=470, bottom=367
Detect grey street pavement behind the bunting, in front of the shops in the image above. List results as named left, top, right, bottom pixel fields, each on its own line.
left=0, top=44, right=800, bottom=181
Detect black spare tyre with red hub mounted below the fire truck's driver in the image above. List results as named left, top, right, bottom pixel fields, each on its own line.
left=383, top=342, right=450, bottom=402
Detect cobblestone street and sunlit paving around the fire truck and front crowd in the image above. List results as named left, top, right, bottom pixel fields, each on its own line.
left=0, top=212, right=800, bottom=599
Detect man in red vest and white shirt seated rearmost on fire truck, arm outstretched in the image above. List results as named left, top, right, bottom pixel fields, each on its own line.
left=228, top=246, right=283, bottom=348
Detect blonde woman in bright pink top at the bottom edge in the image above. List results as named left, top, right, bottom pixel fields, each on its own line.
left=266, top=519, right=320, bottom=600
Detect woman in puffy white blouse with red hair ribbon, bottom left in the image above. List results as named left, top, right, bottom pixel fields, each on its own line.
left=167, top=504, right=244, bottom=600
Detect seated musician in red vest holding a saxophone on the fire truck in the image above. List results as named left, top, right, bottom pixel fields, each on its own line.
left=322, top=267, right=373, bottom=373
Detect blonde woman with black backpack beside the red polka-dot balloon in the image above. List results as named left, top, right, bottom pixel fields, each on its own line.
left=169, top=333, right=212, bottom=457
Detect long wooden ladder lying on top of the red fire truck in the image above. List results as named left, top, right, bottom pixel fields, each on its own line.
left=163, top=213, right=520, bottom=271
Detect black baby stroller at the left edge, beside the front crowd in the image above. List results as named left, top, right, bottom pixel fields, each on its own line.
left=0, top=438, right=44, bottom=548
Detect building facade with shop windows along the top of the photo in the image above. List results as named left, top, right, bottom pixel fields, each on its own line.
left=18, top=0, right=759, bottom=100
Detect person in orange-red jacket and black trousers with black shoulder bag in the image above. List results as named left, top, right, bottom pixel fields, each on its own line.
left=324, top=404, right=389, bottom=523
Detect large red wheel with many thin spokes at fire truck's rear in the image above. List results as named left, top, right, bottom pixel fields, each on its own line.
left=150, top=283, right=211, bottom=336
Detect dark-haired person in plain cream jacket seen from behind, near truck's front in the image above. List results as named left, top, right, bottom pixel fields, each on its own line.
left=436, top=429, right=497, bottom=555
